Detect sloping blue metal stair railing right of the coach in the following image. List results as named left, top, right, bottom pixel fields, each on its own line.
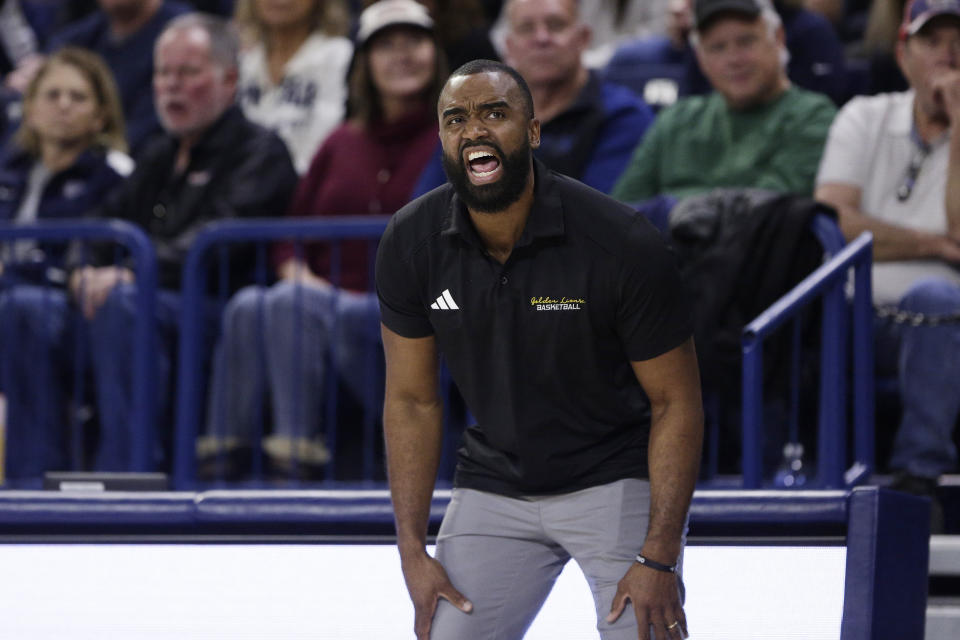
left=742, top=232, right=874, bottom=489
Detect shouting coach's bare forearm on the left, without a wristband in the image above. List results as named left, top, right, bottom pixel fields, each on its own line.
left=383, top=397, right=443, bottom=557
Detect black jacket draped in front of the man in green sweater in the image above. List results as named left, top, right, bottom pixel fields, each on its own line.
left=670, top=189, right=832, bottom=392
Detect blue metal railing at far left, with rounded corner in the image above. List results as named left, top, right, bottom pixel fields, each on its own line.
left=0, top=219, right=157, bottom=471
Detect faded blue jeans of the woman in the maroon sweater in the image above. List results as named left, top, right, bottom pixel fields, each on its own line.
left=207, top=281, right=382, bottom=441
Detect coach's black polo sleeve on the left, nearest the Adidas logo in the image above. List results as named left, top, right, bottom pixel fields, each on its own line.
left=376, top=213, right=433, bottom=338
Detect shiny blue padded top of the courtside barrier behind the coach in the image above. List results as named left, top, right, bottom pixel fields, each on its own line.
left=0, top=489, right=856, bottom=535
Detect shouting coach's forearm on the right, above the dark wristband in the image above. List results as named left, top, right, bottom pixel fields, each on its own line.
left=643, top=402, right=703, bottom=564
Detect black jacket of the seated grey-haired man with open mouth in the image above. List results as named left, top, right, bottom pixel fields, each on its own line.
left=98, top=106, right=297, bottom=289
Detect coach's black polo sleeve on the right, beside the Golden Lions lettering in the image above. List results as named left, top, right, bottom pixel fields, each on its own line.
left=617, top=219, right=693, bottom=361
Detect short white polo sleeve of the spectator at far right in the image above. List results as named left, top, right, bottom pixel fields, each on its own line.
left=816, top=98, right=877, bottom=187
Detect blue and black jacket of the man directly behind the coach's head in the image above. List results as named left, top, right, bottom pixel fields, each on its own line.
left=413, top=72, right=653, bottom=197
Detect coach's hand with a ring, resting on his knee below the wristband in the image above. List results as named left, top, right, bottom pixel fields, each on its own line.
left=607, top=563, right=688, bottom=640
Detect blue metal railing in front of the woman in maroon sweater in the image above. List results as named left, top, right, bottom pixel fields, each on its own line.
left=173, top=216, right=389, bottom=488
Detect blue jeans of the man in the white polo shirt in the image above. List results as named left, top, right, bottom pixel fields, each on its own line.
left=877, top=278, right=960, bottom=478
